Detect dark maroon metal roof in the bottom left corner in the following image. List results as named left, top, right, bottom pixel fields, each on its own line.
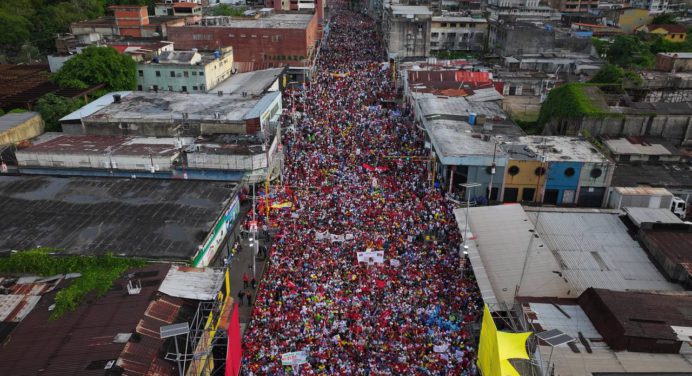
left=0, top=264, right=177, bottom=375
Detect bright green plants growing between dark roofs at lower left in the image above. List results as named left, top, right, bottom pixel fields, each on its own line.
left=0, top=248, right=145, bottom=320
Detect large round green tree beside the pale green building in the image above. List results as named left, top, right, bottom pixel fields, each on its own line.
left=53, top=46, right=137, bottom=90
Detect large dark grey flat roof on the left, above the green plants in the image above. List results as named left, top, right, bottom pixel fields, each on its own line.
left=0, top=176, right=233, bottom=260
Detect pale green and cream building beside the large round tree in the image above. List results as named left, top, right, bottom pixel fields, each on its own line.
left=137, top=47, right=233, bottom=93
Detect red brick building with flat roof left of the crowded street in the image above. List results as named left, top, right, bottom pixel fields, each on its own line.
left=168, top=13, right=319, bottom=72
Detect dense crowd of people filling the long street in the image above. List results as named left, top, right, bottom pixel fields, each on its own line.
left=243, top=7, right=482, bottom=375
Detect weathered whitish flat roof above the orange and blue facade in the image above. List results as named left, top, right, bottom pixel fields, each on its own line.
left=516, top=136, right=607, bottom=163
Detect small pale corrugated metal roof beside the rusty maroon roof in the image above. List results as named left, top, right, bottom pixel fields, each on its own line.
left=159, top=266, right=224, bottom=300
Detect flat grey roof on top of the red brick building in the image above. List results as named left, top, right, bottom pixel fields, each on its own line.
left=197, top=13, right=313, bottom=29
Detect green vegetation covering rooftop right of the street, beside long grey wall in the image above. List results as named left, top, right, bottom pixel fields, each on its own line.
left=538, top=83, right=617, bottom=125
